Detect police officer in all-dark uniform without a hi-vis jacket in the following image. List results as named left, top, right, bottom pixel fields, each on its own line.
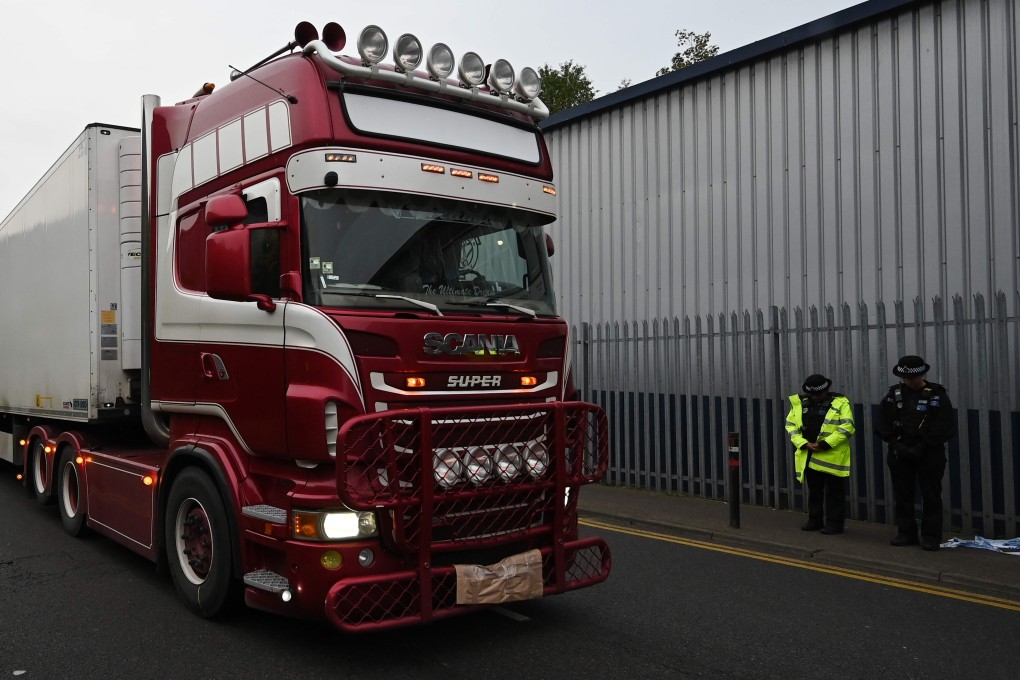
left=875, top=355, right=956, bottom=551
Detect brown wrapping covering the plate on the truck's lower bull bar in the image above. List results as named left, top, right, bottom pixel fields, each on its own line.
left=454, top=550, right=543, bottom=605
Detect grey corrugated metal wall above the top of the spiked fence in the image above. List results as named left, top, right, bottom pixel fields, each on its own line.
left=548, top=0, right=1020, bottom=332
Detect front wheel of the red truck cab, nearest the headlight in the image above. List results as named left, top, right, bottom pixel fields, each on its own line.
left=163, top=469, right=241, bottom=618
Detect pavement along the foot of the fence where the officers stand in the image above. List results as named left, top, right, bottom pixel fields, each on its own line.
left=578, top=484, right=1020, bottom=606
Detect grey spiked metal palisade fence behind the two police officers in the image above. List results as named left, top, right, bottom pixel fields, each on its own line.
left=573, top=292, right=1020, bottom=536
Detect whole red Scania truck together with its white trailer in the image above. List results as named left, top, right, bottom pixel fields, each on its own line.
left=0, top=22, right=610, bottom=631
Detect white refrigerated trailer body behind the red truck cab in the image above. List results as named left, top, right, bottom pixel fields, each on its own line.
left=0, top=123, right=142, bottom=463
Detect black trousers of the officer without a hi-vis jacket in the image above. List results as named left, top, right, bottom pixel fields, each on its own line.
left=887, top=448, right=946, bottom=542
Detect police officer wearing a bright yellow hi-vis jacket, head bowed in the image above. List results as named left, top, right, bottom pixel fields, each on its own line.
left=786, top=373, right=855, bottom=534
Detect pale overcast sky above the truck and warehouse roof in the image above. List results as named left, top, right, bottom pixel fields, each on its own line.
left=0, top=0, right=858, bottom=215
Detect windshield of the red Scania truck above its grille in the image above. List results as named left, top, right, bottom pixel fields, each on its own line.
left=301, top=189, right=556, bottom=315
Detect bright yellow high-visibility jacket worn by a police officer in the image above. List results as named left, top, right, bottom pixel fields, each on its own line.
left=786, top=395, right=856, bottom=483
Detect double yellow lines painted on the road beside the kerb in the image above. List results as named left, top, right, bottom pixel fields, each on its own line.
left=580, top=519, right=1020, bottom=612
